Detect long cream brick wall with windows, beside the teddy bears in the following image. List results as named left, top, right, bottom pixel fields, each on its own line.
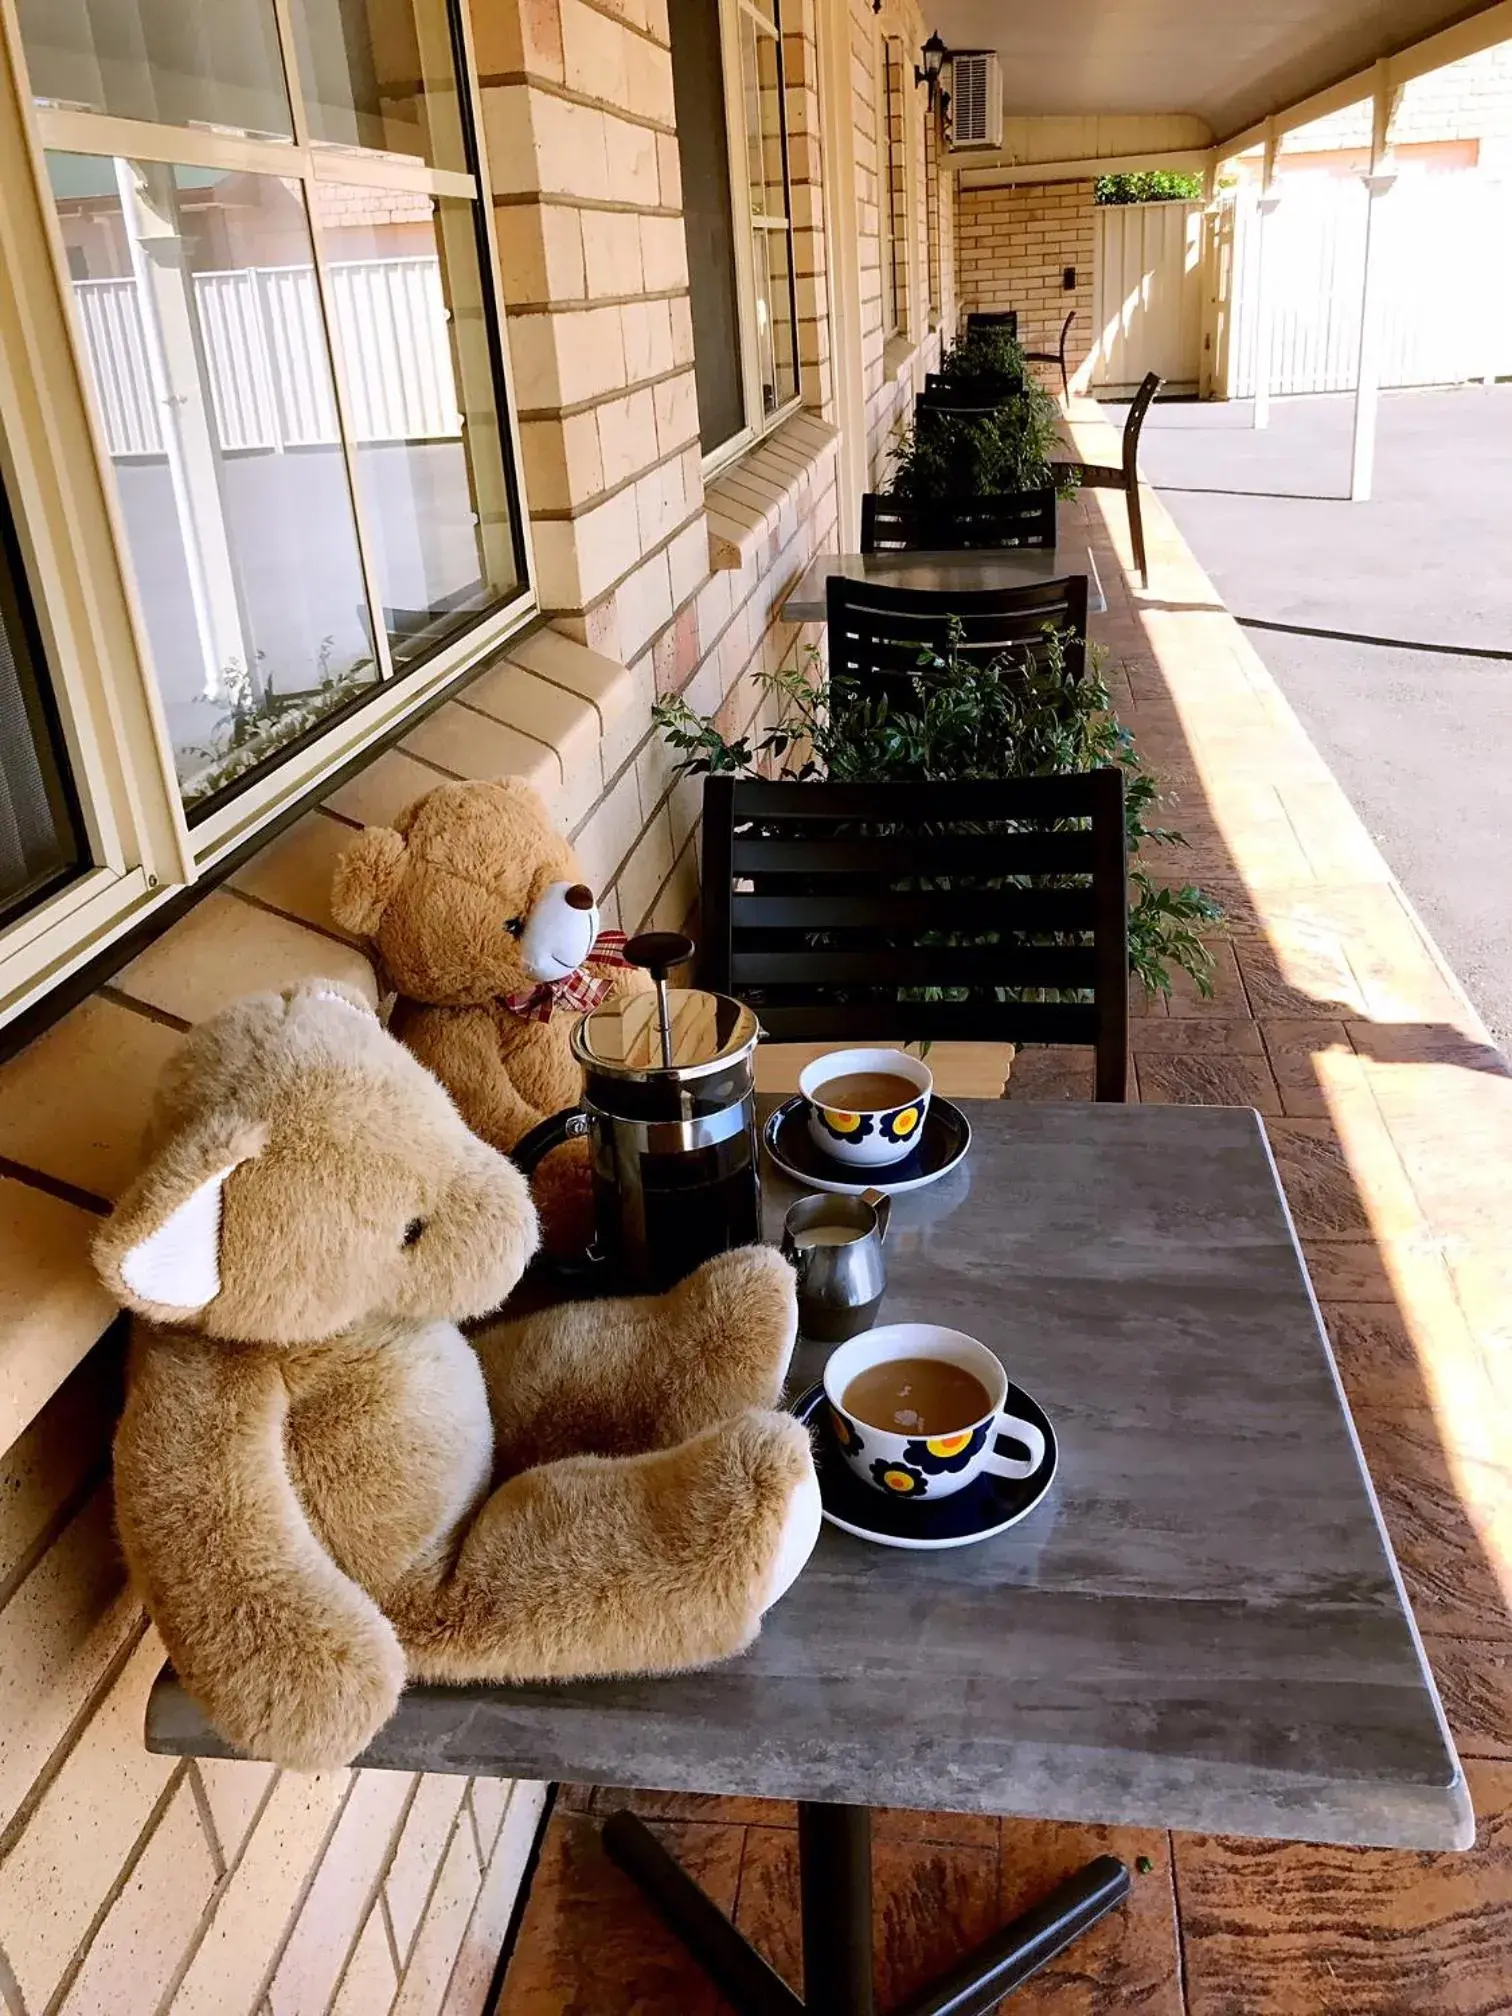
left=0, top=0, right=971, bottom=2016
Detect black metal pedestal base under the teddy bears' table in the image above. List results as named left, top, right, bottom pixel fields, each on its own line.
left=603, top=1802, right=1129, bottom=2016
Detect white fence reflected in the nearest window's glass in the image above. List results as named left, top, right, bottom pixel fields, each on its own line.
left=73, top=258, right=462, bottom=456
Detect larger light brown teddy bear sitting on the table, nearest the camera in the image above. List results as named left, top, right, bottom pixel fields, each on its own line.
left=95, top=982, right=818, bottom=1768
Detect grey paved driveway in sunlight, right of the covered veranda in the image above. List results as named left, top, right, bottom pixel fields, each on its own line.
left=1109, top=385, right=1512, bottom=1048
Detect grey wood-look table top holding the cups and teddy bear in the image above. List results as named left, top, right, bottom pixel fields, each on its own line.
left=149, top=1103, right=1472, bottom=1849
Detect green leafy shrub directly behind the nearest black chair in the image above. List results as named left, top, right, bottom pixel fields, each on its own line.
left=655, top=631, right=1222, bottom=996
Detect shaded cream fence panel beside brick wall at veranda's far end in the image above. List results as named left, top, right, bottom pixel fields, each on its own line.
left=1085, top=204, right=1202, bottom=391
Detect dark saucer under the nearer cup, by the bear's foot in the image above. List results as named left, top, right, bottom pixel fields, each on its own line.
left=792, top=1385, right=1058, bottom=1550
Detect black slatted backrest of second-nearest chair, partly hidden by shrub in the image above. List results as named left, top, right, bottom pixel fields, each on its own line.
left=827, top=575, right=1087, bottom=689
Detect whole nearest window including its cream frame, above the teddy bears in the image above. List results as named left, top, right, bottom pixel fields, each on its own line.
left=0, top=0, right=528, bottom=1020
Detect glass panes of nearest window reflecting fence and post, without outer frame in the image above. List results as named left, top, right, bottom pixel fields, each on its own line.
left=22, top=0, right=522, bottom=823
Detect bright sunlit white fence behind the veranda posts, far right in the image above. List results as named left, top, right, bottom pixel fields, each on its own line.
left=1228, top=169, right=1512, bottom=399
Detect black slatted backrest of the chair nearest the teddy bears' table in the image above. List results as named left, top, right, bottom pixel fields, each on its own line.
left=700, top=770, right=1129, bottom=1099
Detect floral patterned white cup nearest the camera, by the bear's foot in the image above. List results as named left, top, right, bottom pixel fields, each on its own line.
left=825, top=1322, right=1044, bottom=1498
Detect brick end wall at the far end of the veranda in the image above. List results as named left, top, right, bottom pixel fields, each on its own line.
left=958, top=181, right=1095, bottom=391
